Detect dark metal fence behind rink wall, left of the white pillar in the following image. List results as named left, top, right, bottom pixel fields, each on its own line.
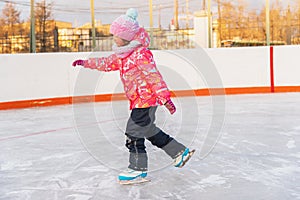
left=0, top=29, right=195, bottom=53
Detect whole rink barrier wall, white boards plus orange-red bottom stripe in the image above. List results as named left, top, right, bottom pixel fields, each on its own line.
left=0, top=46, right=300, bottom=110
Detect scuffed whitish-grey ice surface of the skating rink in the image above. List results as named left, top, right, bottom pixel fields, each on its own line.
left=0, top=93, right=300, bottom=200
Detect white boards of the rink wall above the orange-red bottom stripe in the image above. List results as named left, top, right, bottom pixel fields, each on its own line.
left=0, top=46, right=300, bottom=102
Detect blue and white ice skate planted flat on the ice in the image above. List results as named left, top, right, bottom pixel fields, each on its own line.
left=119, top=169, right=150, bottom=185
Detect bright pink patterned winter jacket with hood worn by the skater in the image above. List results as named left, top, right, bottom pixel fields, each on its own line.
left=84, top=28, right=170, bottom=109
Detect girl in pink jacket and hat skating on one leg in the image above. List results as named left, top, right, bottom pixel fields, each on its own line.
left=73, top=8, right=194, bottom=181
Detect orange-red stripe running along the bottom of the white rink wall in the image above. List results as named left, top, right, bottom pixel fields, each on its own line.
left=0, top=86, right=300, bottom=110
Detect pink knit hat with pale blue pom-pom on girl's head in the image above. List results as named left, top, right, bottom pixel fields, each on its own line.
left=110, top=8, right=140, bottom=41
